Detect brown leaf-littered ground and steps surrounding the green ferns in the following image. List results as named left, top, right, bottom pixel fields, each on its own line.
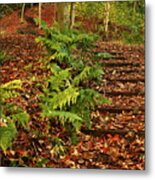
left=0, top=4, right=145, bottom=170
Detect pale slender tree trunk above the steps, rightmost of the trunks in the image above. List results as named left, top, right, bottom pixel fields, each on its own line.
left=104, top=2, right=110, bottom=33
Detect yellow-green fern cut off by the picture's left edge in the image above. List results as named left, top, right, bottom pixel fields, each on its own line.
left=0, top=80, right=29, bottom=152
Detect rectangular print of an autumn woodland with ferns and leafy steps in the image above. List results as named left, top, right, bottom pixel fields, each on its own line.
left=0, top=2, right=145, bottom=170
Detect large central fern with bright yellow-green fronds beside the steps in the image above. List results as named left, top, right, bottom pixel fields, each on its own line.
left=41, top=64, right=109, bottom=141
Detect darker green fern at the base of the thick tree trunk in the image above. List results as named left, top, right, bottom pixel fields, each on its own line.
left=36, top=20, right=97, bottom=68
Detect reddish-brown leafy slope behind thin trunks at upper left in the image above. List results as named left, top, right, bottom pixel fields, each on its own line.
left=0, top=4, right=55, bottom=35
